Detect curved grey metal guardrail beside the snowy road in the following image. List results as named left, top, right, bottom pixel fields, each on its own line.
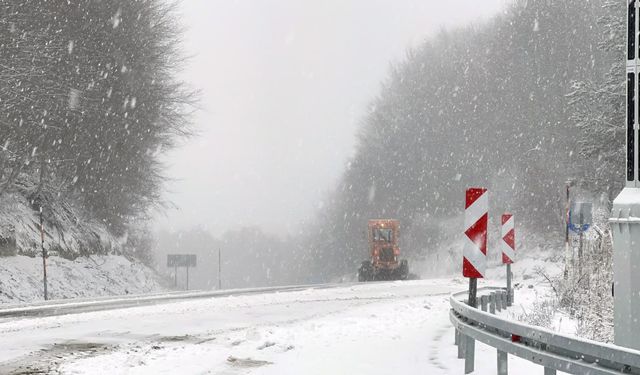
left=449, top=288, right=640, bottom=375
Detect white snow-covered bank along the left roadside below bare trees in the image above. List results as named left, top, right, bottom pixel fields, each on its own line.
left=0, top=255, right=166, bottom=304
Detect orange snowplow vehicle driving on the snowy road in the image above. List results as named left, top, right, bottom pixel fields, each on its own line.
left=358, top=219, right=409, bottom=281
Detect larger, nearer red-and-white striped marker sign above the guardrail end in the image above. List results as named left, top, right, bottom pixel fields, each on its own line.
left=462, top=188, right=489, bottom=278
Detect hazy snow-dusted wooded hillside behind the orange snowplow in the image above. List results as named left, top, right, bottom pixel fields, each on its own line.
left=296, top=0, right=625, bottom=279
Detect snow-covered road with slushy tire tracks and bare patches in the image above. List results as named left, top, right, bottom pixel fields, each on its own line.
left=0, top=279, right=556, bottom=375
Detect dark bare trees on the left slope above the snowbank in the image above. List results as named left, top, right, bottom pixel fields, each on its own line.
left=0, top=0, right=193, bottom=255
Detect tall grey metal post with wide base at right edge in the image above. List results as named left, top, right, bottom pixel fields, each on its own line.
left=609, top=0, right=640, bottom=349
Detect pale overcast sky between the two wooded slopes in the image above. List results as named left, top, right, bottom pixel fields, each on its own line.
left=157, top=0, right=506, bottom=234
